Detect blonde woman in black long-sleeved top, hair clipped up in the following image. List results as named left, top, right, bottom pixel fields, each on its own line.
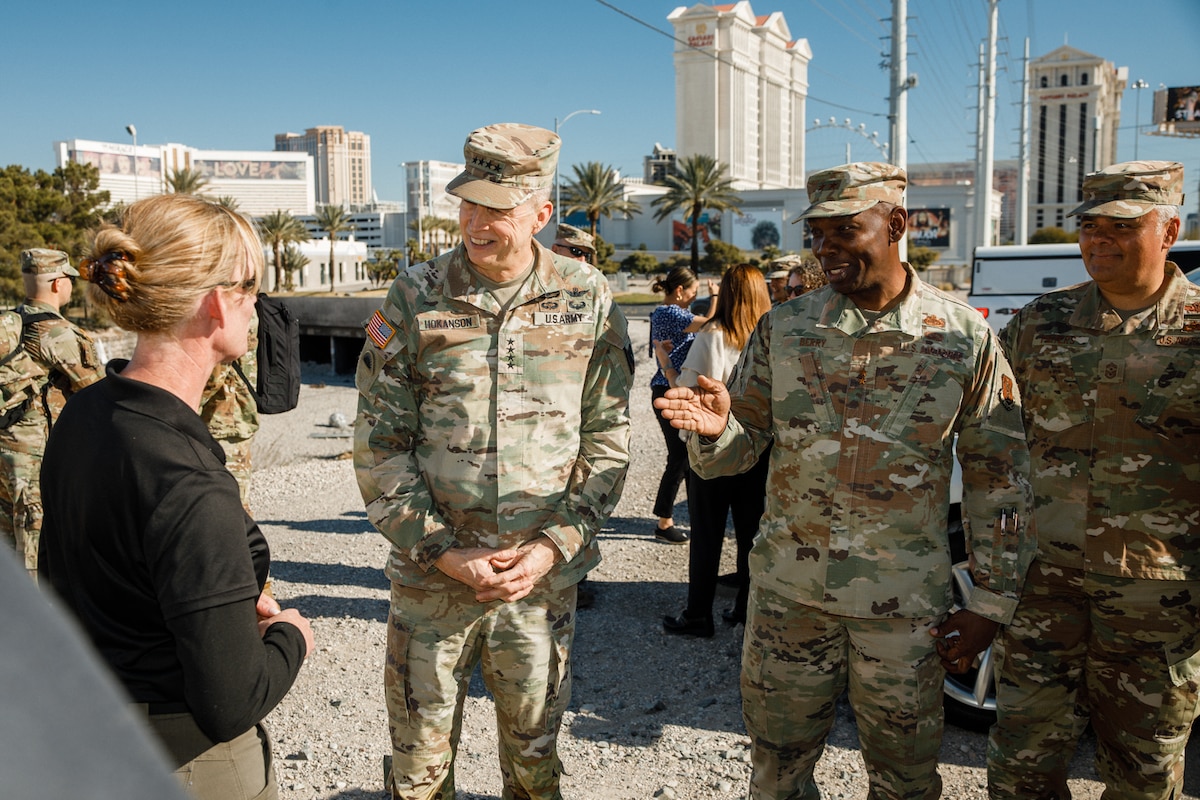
left=38, top=194, right=312, bottom=800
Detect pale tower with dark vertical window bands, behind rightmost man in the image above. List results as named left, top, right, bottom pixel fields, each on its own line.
left=1030, top=44, right=1128, bottom=231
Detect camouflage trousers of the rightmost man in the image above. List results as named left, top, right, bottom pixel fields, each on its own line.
left=988, top=561, right=1200, bottom=800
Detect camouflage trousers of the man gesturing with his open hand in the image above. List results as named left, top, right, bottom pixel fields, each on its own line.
left=742, top=582, right=944, bottom=800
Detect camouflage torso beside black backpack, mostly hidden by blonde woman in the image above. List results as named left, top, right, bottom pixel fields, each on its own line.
left=200, top=314, right=258, bottom=513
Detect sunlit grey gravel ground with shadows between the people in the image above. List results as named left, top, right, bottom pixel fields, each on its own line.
left=251, top=311, right=1200, bottom=800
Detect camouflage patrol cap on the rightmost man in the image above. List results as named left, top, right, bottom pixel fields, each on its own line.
left=1067, top=161, right=1183, bottom=219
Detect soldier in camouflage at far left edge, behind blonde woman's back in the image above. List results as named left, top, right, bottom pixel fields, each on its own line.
left=0, top=248, right=103, bottom=578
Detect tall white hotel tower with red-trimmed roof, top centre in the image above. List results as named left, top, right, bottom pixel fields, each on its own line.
left=667, top=0, right=812, bottom=190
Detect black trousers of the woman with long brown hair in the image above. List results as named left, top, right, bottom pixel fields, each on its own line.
left=684, top=446, right=770, bottom=619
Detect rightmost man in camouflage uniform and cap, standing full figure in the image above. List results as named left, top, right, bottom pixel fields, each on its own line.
left=988, top=161, right=1200, bottom=800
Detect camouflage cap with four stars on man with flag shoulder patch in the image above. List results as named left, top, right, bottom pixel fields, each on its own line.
left=446, top=122, right=562, bottom=209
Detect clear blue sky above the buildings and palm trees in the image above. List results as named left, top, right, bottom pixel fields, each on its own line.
left=0, top=0, right=1200, bottom=207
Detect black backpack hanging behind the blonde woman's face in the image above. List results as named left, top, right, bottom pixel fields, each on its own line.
left=233, top=294, right=300, bottom=414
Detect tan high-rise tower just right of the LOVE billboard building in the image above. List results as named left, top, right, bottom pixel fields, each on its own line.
left=275, top=125, right=374, bottom=207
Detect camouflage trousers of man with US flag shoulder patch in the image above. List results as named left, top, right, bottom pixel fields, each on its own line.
left=384, top=583, right=576, bottom=800
